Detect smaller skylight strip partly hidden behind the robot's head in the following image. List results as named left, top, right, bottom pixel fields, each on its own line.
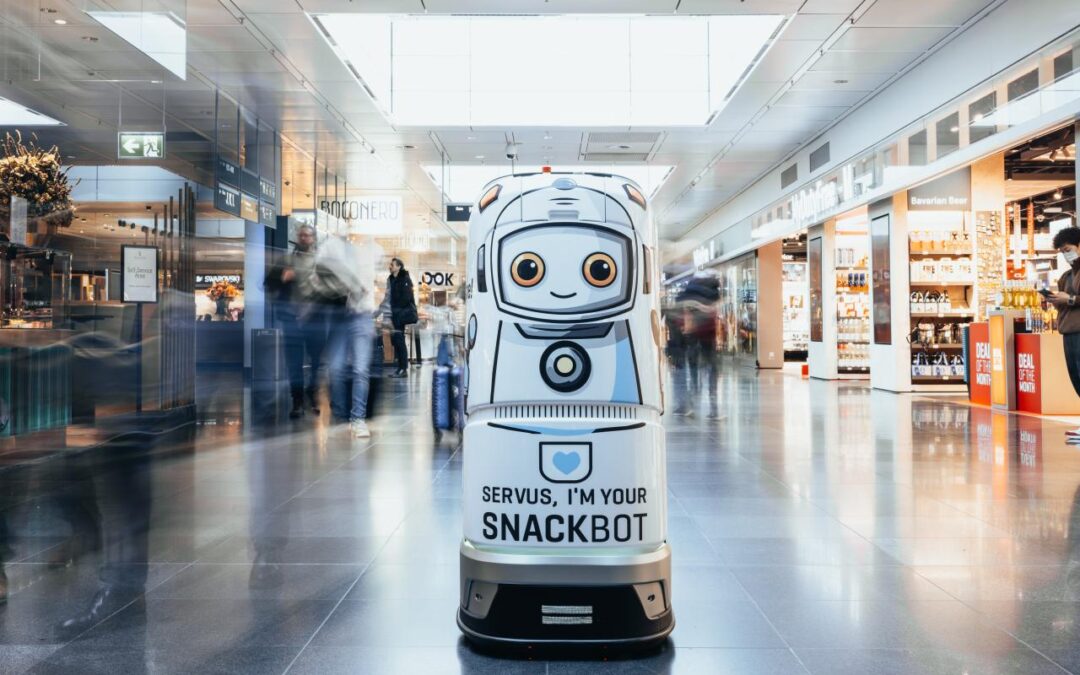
left=423, top=164, right=673, bottom=203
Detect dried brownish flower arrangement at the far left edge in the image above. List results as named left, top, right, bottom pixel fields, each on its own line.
left=0, top=132, right=76, bottom=227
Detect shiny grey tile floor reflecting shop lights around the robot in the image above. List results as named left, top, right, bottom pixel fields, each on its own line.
left=0, top=367, right=1080, bottom=675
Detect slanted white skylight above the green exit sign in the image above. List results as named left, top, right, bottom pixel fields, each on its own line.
left=86, top=10, right=188, bottom=80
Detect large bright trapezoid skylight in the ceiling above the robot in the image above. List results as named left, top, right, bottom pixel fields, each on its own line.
left=310, top=14, right=784, bottom=127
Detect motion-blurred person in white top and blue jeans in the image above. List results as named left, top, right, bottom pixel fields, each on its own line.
left=311, top=237, right=381, bottom=438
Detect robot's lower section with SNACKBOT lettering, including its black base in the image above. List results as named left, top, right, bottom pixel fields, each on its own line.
left=458, top=406, right=674, bottom=645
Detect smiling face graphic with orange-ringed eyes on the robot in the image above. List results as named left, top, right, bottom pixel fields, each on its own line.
left=498, top=224, right=634, bottom=314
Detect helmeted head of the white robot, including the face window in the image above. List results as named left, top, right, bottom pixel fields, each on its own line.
left=470, top=174, right=649, bottom=322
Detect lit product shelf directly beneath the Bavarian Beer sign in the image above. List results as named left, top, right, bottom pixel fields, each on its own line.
left=908, top=212, right=975, bottom=384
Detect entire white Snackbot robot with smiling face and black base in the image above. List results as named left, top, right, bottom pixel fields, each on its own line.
left=458, top=172, right=674, bottom=645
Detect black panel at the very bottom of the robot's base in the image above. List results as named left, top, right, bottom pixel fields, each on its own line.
left=458, top=584, right=675, bottom=649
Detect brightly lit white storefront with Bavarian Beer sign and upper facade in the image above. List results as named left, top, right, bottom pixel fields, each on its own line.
left=670, top=30, right=1080, bottom=392
